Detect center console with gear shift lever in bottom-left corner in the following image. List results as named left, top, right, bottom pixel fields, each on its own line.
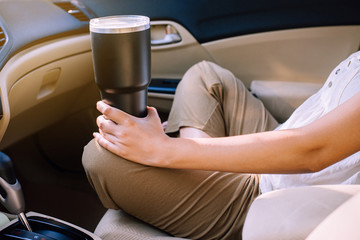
left=0, top=152, right=101, bottom=240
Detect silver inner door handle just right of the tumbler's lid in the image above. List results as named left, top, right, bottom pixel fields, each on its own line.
left=151, top=24, right=181, bottom=46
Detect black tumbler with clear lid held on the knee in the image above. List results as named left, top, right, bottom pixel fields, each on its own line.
left=90, top=15, right=151, bottom=117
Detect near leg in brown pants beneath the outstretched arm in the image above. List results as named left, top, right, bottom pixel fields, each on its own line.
left=83, top=141, right=259, bottom=239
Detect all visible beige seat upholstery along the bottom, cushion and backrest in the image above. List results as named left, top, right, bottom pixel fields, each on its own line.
left=95, top=185, right=360, bottom=240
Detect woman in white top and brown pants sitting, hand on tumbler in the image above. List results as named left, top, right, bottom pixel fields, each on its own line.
left=83, top=52, right=360, bottom=239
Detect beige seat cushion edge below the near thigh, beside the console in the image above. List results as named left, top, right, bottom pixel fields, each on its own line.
left=95, top=209, right=187, bottom=240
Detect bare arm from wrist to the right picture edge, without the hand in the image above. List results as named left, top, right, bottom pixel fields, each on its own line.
left=164, top=94, right=360, bottom=173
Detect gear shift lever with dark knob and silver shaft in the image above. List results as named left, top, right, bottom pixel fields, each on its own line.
left=0, top=152, right=32, bottom=232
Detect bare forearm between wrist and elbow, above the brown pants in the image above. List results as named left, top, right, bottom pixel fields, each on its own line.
left=164, top=129, right=312, bottom=173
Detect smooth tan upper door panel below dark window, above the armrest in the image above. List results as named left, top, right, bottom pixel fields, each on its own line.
left=203, top=26, right=360, bottom=86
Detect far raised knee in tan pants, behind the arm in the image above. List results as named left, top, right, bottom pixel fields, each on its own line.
left=166, top=61, right=278, bottom=137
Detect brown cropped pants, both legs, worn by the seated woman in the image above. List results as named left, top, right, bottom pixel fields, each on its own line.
left=83, top=62, right=277, bottom=239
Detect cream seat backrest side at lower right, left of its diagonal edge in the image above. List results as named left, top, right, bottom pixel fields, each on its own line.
left=243, top=185, right=360, bottom=240
